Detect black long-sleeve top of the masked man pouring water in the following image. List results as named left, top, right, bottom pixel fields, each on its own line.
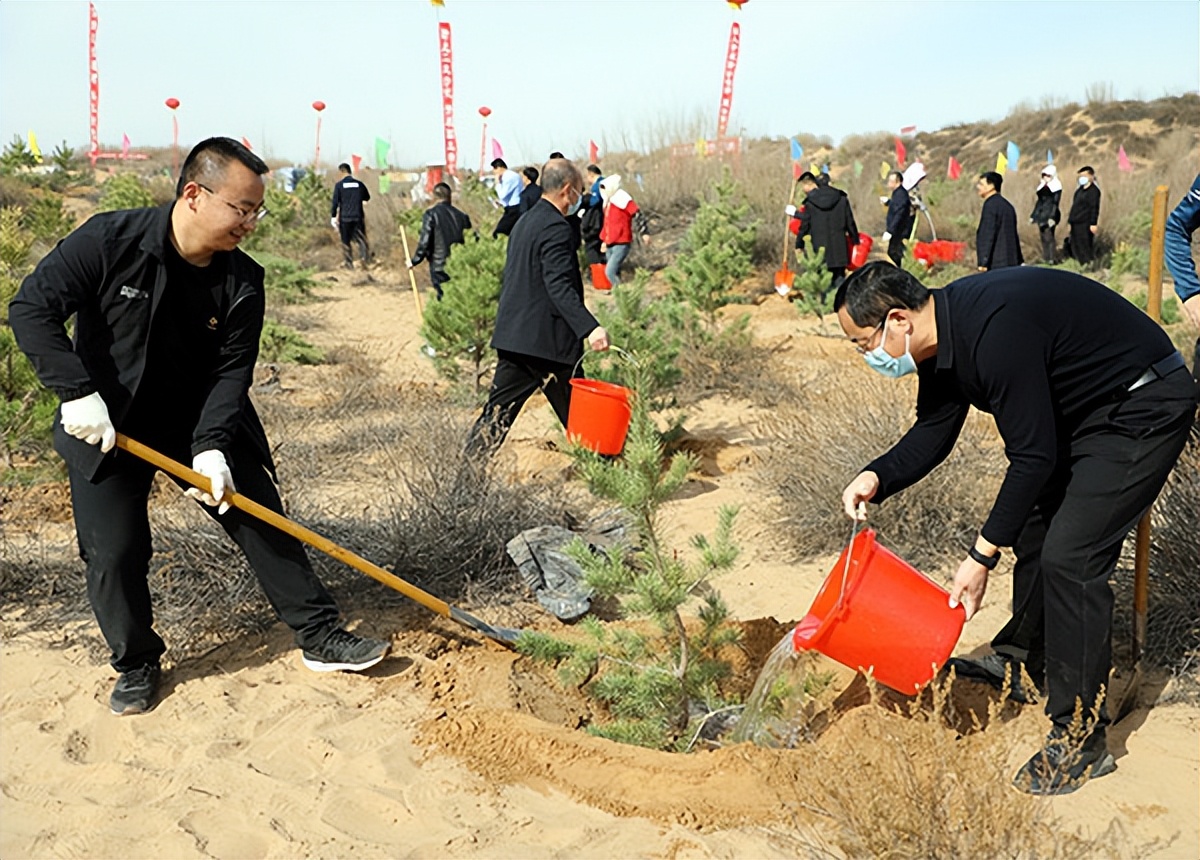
left=865, top=267, right=1175, bottom=547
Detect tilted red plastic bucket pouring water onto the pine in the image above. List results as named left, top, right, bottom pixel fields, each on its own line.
left=792, top=529, right=966, bottom=694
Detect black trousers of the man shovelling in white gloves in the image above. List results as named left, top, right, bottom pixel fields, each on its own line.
left=67, top=431, right=338, bottom=672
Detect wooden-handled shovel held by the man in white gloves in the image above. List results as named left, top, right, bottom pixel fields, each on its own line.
left=116, top=433, right=521, bottom=646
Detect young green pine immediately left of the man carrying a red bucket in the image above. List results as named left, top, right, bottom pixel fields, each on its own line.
left=421, top=236, right=508, bottom=397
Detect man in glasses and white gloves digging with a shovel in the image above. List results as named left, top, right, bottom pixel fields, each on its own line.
left=8, top=138, right=390, bottom=715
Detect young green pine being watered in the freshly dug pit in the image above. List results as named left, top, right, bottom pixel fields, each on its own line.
left=517, top=364, right=738, bottom=750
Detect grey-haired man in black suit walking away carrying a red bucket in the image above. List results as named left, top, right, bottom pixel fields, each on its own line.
left=466, top=158, right=608, bottom=456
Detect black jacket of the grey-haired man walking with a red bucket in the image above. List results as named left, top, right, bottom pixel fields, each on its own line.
left=492, top=199, right=599, bottom=365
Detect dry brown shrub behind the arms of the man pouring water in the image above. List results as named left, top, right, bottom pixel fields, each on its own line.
left=756, top=362, right=1004, bottom=571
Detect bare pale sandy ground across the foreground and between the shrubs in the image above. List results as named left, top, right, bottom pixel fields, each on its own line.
left=0, top=269, right=1200, bottom=858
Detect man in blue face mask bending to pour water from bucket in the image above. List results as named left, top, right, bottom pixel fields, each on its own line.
left=834, top=263, right=1196, bottom=794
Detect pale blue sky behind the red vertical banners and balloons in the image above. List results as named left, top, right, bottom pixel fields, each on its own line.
left=0, top=0, right=1200, bottom=167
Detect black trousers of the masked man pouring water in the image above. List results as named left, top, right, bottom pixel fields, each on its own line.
left=991, top=368, right=1196, bottom=729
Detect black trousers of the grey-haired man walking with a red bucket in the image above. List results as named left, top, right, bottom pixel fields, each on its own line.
left=467, top=350, right=583, bottom=455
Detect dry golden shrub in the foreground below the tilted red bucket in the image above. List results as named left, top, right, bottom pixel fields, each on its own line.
left=797, top=680, right=1137, bottom=860
